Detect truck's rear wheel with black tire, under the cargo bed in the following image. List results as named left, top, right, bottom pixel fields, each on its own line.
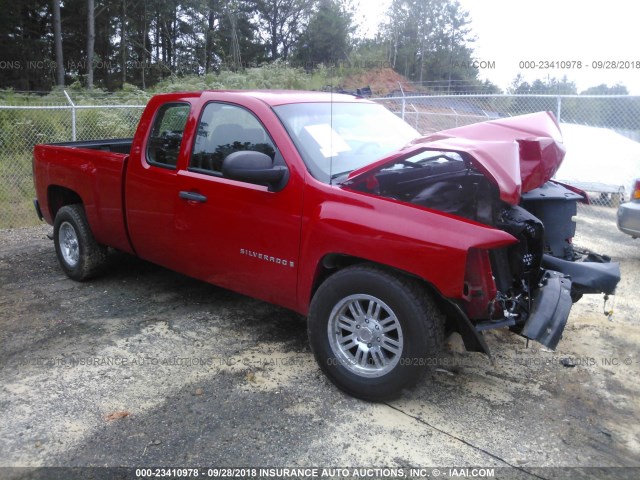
left=53, top=204, right=107, bottom=282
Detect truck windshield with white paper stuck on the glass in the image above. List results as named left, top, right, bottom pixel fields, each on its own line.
left=275, top=103, right=420, bottom=183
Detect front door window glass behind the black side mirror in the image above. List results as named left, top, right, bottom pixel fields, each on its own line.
left=189, top=103, right=276, bottom=175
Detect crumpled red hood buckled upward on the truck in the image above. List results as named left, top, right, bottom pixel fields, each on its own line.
left=348, top=112, right=565, bottom=205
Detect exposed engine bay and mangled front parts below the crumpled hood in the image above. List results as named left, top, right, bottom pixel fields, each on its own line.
left=349, top=150, right=620, bottom=348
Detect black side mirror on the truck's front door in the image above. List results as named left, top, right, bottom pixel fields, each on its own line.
left=222, top=150, right=288, bottom=192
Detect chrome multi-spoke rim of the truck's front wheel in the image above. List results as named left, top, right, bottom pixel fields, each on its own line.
left=327, top=294, right=404, bottom=378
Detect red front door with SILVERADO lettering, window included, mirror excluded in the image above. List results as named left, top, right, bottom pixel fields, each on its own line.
left=174, top=100, right=304, bottom=308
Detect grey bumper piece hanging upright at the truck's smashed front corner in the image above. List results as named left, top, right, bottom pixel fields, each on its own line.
left=520, top=270, right=572, bottom=350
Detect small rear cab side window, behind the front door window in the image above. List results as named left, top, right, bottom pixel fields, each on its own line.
left=147, top=103, right=189, bottom=168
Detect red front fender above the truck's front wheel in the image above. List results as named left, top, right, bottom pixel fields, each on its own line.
left=299, top=182, right=516, bottom=311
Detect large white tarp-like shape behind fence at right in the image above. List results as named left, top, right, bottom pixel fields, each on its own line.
left=554, top=123, right=640, bottom=199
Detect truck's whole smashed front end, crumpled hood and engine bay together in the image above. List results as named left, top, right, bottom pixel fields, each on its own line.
left=343, top=113, right=620, bottom=353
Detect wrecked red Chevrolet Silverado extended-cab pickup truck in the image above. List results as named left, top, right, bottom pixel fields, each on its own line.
left=33, top=91, right=619, bottom=401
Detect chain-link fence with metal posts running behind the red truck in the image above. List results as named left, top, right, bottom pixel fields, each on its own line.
left=0, top=92, right=640, bottom=233
